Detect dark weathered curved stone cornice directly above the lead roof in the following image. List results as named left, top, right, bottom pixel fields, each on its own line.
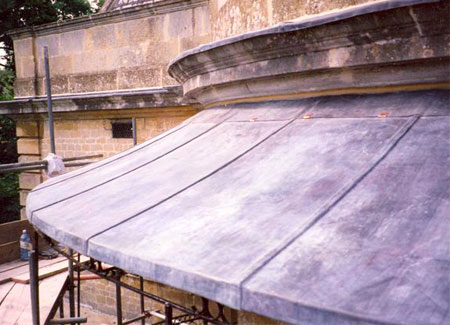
left=169, top=0, right=450, bottom=105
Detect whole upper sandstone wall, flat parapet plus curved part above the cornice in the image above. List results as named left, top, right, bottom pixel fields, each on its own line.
left=14, top=0, right=386, bottom=97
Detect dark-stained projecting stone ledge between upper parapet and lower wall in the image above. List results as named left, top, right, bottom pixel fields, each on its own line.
left=0, top=86, right=189, bottom=115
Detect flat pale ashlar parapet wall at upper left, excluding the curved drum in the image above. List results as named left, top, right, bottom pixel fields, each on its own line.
left=14, top=4, right=210, bottom=97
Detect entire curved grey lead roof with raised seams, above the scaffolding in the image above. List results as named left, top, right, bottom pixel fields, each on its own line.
left=28, top=90, right=450, bottom=325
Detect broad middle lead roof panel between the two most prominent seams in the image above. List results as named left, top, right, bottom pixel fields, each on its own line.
left=88, top=119, right=405, bottom=308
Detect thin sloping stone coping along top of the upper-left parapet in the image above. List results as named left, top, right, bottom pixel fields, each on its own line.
left=7, top=0, right=208, bottom=40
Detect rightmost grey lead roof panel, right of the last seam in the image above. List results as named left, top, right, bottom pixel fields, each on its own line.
left=242, top=117, right=450, bottom=324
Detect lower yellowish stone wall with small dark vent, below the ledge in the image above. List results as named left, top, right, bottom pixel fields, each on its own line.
left=16, top=107, right=196, bottom=219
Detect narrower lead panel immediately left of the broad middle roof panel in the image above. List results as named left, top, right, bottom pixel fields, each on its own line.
left=29, top=122, right=282, bottom=254
